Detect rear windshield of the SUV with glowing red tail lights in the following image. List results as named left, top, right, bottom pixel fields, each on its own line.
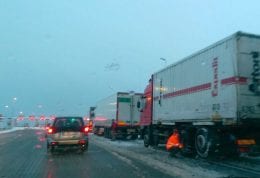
left=53, top=117, right=84, bottom=131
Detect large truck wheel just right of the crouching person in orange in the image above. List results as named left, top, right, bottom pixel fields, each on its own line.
left=195, top=128, right=211, bottom=158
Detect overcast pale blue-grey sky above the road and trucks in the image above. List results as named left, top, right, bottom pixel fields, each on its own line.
left=0, top=0, right=260, bottom=115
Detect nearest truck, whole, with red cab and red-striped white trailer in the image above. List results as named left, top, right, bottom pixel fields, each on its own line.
left=138, top=32, right=260, bottom=158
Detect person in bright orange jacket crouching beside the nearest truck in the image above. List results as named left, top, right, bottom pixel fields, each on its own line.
left=166, top=129, right=183, bottom=154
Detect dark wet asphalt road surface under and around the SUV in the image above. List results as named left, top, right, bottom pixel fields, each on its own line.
left=0, top=129, right=175, bottom=178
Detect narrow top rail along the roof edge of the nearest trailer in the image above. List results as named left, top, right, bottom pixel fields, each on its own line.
left=153, top=31, right=260, bottom=75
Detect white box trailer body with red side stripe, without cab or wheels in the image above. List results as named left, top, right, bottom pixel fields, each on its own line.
left=153, top=32, right=260, bottom=125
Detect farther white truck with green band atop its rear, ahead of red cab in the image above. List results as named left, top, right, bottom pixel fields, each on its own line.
left=93, top=92, right=142, bottom=138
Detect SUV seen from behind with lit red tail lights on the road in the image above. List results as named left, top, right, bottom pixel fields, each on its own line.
left=47, top=117, right=89, bottom=152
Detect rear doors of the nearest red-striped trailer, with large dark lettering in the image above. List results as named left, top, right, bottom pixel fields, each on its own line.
left=238, top=36, right=260, bottom=122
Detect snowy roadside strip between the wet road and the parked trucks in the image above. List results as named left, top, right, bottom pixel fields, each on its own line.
left=90, top=135, right=227, bottom=178
